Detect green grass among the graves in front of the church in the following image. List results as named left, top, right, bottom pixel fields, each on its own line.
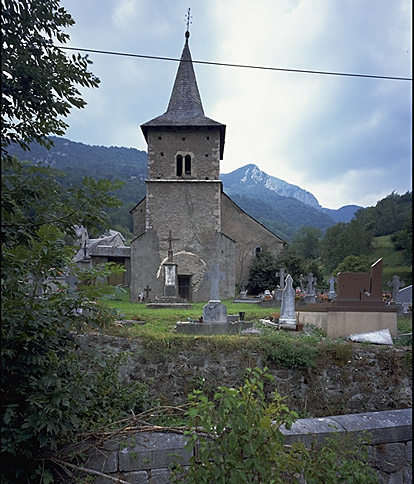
left=99, top=293, right=412, bottom=354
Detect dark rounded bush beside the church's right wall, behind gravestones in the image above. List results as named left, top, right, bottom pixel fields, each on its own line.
left=246, top=247, right=277, bottom=294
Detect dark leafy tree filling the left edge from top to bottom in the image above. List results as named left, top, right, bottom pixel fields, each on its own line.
left=0, top=0, right=147, bottom=483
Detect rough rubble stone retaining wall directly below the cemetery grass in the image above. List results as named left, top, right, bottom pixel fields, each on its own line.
left=80, top=333, right=412, bottom=417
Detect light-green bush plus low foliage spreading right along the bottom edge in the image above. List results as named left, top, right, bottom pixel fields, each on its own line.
left=175, top=368, right=377, bottom=484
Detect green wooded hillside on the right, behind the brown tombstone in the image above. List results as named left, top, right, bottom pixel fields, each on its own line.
left=266, top=192, right=412, bottom=294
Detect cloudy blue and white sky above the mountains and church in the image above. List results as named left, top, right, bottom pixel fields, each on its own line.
left=61, top=0, right=412, bottom=209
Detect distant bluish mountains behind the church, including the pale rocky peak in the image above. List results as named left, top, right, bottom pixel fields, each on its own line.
left=9, top=137, right=359, bottom=241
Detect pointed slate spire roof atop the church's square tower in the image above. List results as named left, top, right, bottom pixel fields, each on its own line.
left=141, top=31, right=226, bottom=158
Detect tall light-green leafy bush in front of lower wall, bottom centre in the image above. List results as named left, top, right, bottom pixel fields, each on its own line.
left=181, top=368, right=297, bottom=484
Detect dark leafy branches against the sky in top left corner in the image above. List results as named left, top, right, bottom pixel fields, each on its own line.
left=1, top=0, right=99, bottom=149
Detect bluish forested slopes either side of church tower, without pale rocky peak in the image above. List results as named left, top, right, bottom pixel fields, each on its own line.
left=10, top=136, right=335, bottom=241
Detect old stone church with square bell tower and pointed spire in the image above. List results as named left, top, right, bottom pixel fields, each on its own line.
left=131, top=29, right=285, bottom=302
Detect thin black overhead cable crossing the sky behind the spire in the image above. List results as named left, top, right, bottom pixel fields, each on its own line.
left=55, top=45, right=412, bottom=81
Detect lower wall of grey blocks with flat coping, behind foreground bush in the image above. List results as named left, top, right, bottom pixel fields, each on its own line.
left=67, top=409, right=412, bottom=484
